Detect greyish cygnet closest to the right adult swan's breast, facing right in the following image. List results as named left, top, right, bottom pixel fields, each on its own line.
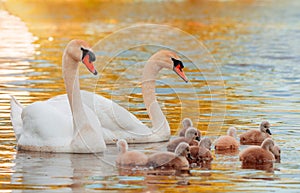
left=167, top=127, right=199, bottom=152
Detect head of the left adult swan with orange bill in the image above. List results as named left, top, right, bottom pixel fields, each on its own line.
left=65, top=40, right=97, bottom=75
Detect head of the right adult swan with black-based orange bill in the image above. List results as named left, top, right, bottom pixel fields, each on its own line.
left=149, top=50, right=188, bottom=82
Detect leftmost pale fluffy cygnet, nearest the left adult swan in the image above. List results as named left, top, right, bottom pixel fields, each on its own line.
left=116, top=139, right=148, bottom=167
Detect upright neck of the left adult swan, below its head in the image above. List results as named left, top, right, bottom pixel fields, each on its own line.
left=62, top=53, right=87, bottom=135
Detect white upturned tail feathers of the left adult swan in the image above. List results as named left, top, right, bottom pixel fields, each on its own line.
left=10, top=96, right=24, bottom=141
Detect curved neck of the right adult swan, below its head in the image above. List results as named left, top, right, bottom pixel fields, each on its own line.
left=142, top=59, right=170, bottom=130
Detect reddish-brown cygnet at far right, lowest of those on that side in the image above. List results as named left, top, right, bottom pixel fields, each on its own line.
left=239, top=138, right=275, bottom=164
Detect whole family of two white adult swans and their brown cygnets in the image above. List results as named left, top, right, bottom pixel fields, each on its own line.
left=11, top=40, right=281, bottom=172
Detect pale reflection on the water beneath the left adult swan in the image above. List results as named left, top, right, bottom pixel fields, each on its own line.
left=11, top=151, right=117, bottom=192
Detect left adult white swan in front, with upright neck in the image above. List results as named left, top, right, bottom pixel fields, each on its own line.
left=11, top=40, right=106, bottom=153
